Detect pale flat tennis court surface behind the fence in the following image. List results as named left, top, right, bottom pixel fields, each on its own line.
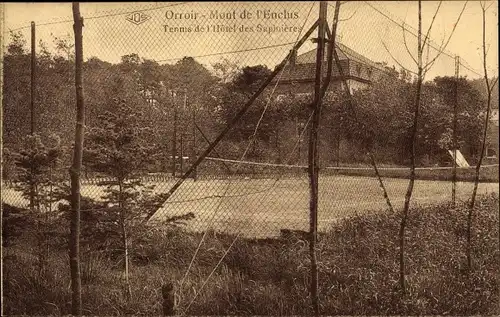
left=2, top=174, right=498, bottom=237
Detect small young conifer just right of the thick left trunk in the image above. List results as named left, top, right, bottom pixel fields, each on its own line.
left=84, top=100, right=153, bottom=297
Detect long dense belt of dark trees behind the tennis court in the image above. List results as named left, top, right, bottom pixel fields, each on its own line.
left=3, top=33, right=498, bottom=172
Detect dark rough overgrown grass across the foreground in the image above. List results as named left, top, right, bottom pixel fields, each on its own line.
left=4, top=194, right=500, bottom=316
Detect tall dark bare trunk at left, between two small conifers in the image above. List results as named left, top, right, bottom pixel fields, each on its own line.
left=69, top=2, right=85, bottom=316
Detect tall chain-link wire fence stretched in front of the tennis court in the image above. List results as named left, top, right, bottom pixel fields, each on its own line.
left=2, top=2, right=498, bottom=314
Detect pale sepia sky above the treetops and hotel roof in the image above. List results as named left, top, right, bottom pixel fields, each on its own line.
left=4, top=1, right=498, bottom=78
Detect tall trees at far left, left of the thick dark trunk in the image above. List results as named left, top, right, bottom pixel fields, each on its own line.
left=2, top=33, right=74, bottom=150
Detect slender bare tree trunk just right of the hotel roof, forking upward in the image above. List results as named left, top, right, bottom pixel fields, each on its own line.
left=399, top=1, right=423, bottom=294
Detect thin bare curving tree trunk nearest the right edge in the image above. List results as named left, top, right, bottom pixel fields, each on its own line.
left=467, top=2, right=498, bottom=271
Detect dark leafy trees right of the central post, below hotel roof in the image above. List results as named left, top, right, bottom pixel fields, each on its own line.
left=324, top=72, right=483, bottom=166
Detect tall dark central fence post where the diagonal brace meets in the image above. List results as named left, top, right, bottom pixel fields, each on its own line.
left=308, top=1, right=328, bottom=316
